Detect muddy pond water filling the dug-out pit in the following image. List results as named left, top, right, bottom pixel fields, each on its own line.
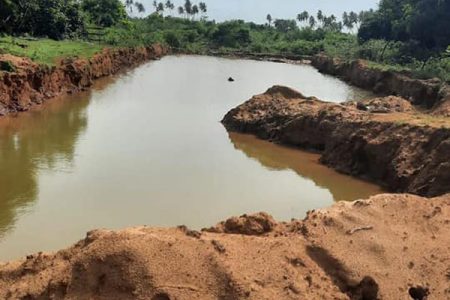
left=0, top=56, right=382, bottom=260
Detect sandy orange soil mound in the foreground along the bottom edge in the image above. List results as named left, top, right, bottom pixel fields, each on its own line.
left=0, top=194, right=450, bottom=300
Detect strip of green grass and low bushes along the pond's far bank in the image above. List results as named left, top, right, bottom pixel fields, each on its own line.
left=0, top=14, right=450, bottom=82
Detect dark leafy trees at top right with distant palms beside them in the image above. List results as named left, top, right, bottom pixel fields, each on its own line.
left=266, top=0, right=450, bottom=61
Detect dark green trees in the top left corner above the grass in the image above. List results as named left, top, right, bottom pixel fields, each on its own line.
left=0, top=0, right=145, bottom=39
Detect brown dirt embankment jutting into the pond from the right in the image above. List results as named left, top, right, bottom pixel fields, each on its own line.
left=222, top=86, right=450, bottom=196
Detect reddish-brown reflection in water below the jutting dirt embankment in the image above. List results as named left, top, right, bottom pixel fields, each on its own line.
left=229, top=133, right=382, bottom=201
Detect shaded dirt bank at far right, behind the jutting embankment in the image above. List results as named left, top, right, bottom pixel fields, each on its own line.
left=312, top=55, right=450, bottom=116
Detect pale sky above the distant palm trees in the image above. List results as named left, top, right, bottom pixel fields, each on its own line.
left=134, top=0, right=379, bottom=23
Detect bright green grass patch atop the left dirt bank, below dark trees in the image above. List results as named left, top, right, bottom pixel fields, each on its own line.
left=0, top=36, right=105, bottom=65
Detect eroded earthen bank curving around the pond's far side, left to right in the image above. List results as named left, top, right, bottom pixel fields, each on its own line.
left=0, top=44, right=450, bottom=118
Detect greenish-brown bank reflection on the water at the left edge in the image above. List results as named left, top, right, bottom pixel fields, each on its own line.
left=0, top=79, right=116, bottom=238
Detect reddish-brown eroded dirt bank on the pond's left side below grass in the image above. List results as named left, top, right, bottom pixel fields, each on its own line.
left=0, top=45, right=168, bottom=116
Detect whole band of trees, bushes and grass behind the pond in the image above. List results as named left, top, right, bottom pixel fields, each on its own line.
left=0, top=0, right=450, bottom=82
